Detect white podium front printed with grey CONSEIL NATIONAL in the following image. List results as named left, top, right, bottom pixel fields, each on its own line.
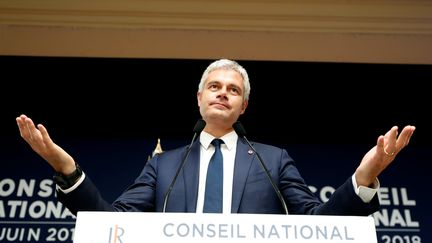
left=74, top=212, right=377, bottom=243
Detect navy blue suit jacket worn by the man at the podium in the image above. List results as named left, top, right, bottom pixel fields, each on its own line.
left=57, top=138, right=379, bottom=216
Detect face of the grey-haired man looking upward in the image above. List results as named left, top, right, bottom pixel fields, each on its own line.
left=197, top=69, right=248, bottom=127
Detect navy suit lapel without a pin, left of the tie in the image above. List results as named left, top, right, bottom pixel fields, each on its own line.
left=183, top=139, right=201, bottom=212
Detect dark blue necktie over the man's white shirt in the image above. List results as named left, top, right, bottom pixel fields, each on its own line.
left=203, top=139, right=223, bottom=213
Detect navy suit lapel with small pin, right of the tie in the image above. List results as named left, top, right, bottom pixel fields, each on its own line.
left=231, top=138, right=255, bottom=213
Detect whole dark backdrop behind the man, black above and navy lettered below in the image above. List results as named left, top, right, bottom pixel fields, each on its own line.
left=0, top=56, right=432, bottom=243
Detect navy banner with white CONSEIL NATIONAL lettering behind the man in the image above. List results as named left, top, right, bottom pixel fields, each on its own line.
left=0, top=137, right=432, bottom=243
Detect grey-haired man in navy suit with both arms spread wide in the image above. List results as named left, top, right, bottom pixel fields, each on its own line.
left=17, top=59, right=415, bottom=215
